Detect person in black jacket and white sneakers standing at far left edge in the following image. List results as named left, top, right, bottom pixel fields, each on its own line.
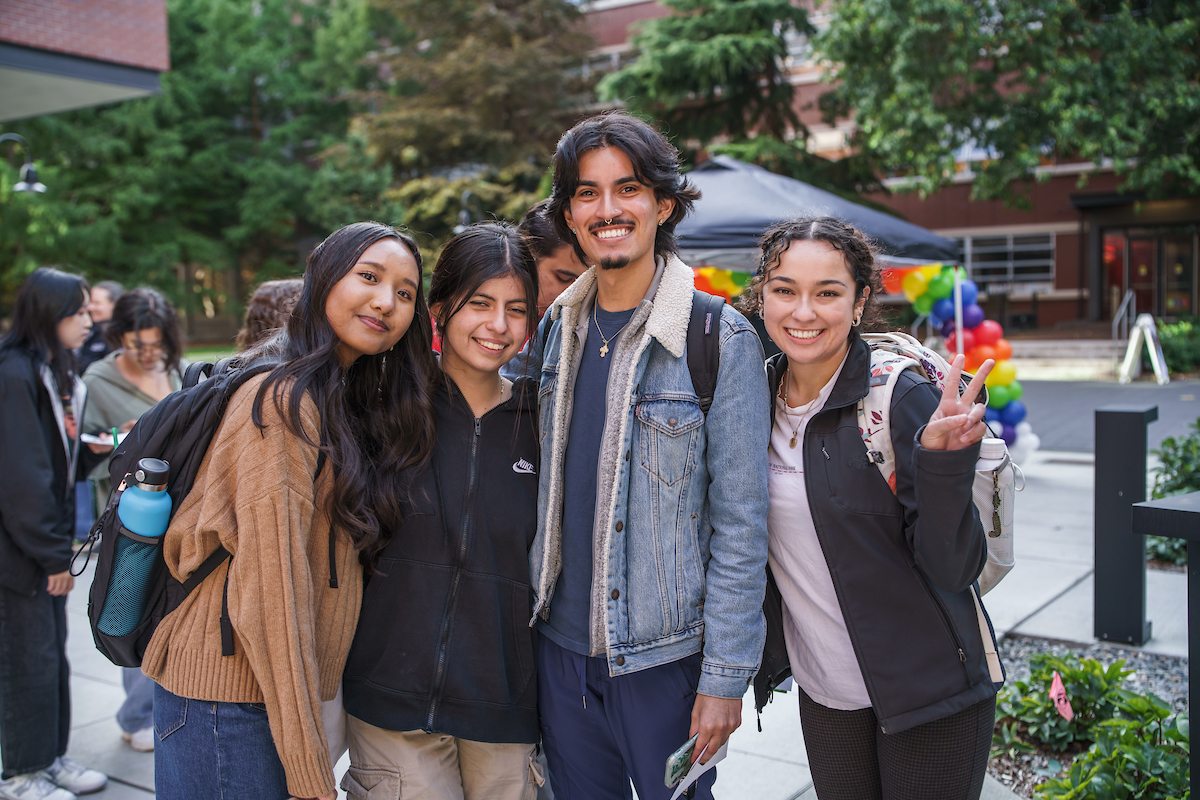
left=0, top=267, right=108, bottom=800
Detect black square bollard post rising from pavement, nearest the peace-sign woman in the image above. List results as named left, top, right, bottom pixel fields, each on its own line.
left=1093, top=405, right=1158, bottom=645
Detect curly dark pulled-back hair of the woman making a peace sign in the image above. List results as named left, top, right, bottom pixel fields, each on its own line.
left=738, top=217, right=886, bottom=331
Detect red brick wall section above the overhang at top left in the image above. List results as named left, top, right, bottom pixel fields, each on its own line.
left=0, top=0, right=170, bottom=72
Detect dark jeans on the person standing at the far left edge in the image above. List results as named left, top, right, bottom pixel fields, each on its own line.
left=0, top=585, right=71, bottom=780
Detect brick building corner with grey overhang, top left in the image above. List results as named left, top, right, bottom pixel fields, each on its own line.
left=0, top=0, right=170, bottom=122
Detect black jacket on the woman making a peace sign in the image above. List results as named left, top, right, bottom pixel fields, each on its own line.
left=755, top=333, right=996, bottom=733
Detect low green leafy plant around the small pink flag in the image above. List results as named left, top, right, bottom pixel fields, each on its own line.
left=996, top=655, right=1133, bottom=752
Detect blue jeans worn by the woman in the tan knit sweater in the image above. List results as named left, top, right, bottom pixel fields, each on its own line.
left=154, top=684, right=290, bottom=800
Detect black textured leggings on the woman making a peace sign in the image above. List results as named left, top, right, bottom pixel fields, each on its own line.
left=800, top=690, right=996, bottom=800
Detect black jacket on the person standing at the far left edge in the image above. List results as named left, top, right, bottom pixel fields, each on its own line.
left=0, top=348, right=100, bottom=596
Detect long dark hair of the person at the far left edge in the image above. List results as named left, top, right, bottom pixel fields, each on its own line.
left=0, top=266, right=88, bottom=395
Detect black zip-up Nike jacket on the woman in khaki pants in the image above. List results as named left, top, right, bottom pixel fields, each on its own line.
left=342, top=379, right=540, bottom=744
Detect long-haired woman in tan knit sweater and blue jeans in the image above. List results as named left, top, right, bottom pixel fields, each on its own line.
left=143, top=223, right=437, bottom=800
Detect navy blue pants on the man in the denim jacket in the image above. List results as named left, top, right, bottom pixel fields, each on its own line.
left=538, top=634, right=716, bottom=800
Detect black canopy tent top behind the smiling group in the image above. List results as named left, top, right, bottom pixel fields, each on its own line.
left=676, top=156, right=959, bottom=271
